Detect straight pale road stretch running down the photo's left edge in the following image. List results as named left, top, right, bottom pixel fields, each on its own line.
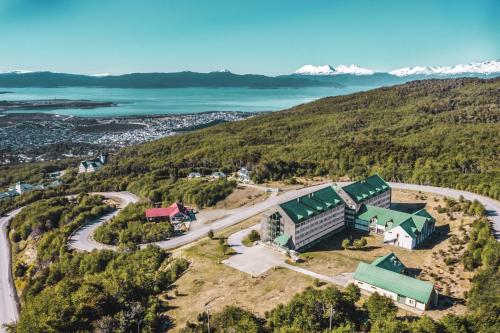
left=0, top=208, right=23, bottom=332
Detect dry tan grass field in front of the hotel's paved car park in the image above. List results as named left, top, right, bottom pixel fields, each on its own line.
left=167, top=216, right=313, bottom=332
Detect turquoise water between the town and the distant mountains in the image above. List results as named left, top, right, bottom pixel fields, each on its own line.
left=0, top=87, right=371, bottom=117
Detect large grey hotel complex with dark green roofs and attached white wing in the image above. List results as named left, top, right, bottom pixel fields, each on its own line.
left=260, top=175, right=435, bottom=250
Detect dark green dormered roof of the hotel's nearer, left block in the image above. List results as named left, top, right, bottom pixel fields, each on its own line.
left=280, top=186, right=344, bottom=223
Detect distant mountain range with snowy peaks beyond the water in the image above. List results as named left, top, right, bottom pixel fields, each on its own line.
left=0, top=60, right=500, bottom=89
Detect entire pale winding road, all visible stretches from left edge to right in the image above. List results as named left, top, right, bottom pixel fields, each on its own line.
left=0, top=183, right=500, bottom=332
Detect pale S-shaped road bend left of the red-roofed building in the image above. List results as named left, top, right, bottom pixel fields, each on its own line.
left=69, top=192, right=139, bottom=251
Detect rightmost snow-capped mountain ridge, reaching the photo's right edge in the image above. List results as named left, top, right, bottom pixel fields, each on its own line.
left=389, top=60, right=500, bottom=76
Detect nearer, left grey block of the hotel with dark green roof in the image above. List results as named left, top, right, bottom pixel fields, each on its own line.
left=260, top=186, right=345, bottom=250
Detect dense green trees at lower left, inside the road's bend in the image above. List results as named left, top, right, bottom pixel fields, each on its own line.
left=8, top=194, right=189, bottom=333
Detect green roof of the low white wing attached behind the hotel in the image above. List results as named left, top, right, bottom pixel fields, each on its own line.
left=356, top=205, right=434, bottom=238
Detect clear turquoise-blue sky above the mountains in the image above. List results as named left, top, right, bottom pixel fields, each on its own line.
left=0, top=0, right=500, bottom=75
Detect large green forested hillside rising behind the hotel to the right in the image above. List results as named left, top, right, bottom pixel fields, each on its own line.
left=51, top=78, right=500, bottom=198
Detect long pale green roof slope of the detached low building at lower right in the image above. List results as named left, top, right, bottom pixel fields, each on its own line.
left=354, top=262, right=434, bottom=304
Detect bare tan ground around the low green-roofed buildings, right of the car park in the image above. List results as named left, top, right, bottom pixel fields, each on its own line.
left=298, top=190, right=472, bottom=318
